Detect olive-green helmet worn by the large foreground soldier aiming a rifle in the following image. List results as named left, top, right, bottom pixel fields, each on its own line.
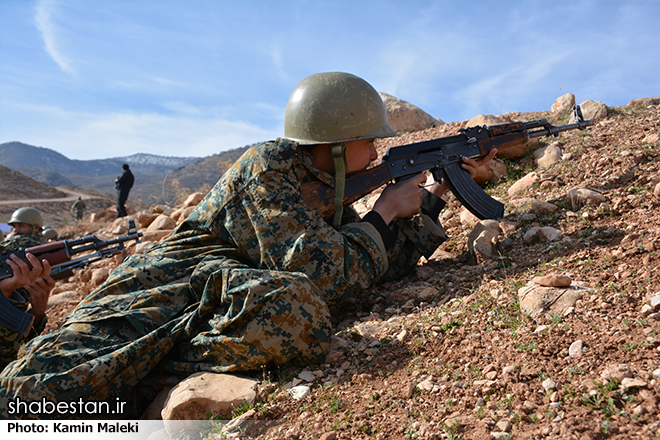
left=284, top=72, right=397, bottom=145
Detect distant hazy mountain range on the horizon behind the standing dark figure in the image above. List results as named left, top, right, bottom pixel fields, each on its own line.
left=0, top=142, right=250, bottom=204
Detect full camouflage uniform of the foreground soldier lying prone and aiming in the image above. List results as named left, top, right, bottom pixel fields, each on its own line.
left=0, top=139, right=446, bottom=417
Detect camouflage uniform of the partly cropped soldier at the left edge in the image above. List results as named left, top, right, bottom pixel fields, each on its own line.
left=0, top=234, right=48, bottom=369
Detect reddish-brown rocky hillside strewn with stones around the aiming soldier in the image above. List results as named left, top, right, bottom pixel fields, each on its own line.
left=15, top=94, right=660, bottom=440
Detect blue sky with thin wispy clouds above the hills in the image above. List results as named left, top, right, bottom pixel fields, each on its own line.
left=0, top=0, right=660, bottom=159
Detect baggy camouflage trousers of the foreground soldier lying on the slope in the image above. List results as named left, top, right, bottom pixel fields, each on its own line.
left=0, top=256, right=332, bottom=419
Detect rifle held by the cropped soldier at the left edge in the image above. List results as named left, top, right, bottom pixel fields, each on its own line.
left=0, top=219, right=143, bottom=336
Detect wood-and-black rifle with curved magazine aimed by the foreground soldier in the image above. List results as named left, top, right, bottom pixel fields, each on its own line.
left=302, top=106, right=593, bottom=220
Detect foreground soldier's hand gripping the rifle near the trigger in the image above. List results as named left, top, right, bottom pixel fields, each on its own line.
left=373, top=174, right=426, bottom=225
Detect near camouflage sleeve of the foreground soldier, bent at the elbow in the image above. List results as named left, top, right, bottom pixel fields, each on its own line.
left=225, top=171, right=388, bottom=304
